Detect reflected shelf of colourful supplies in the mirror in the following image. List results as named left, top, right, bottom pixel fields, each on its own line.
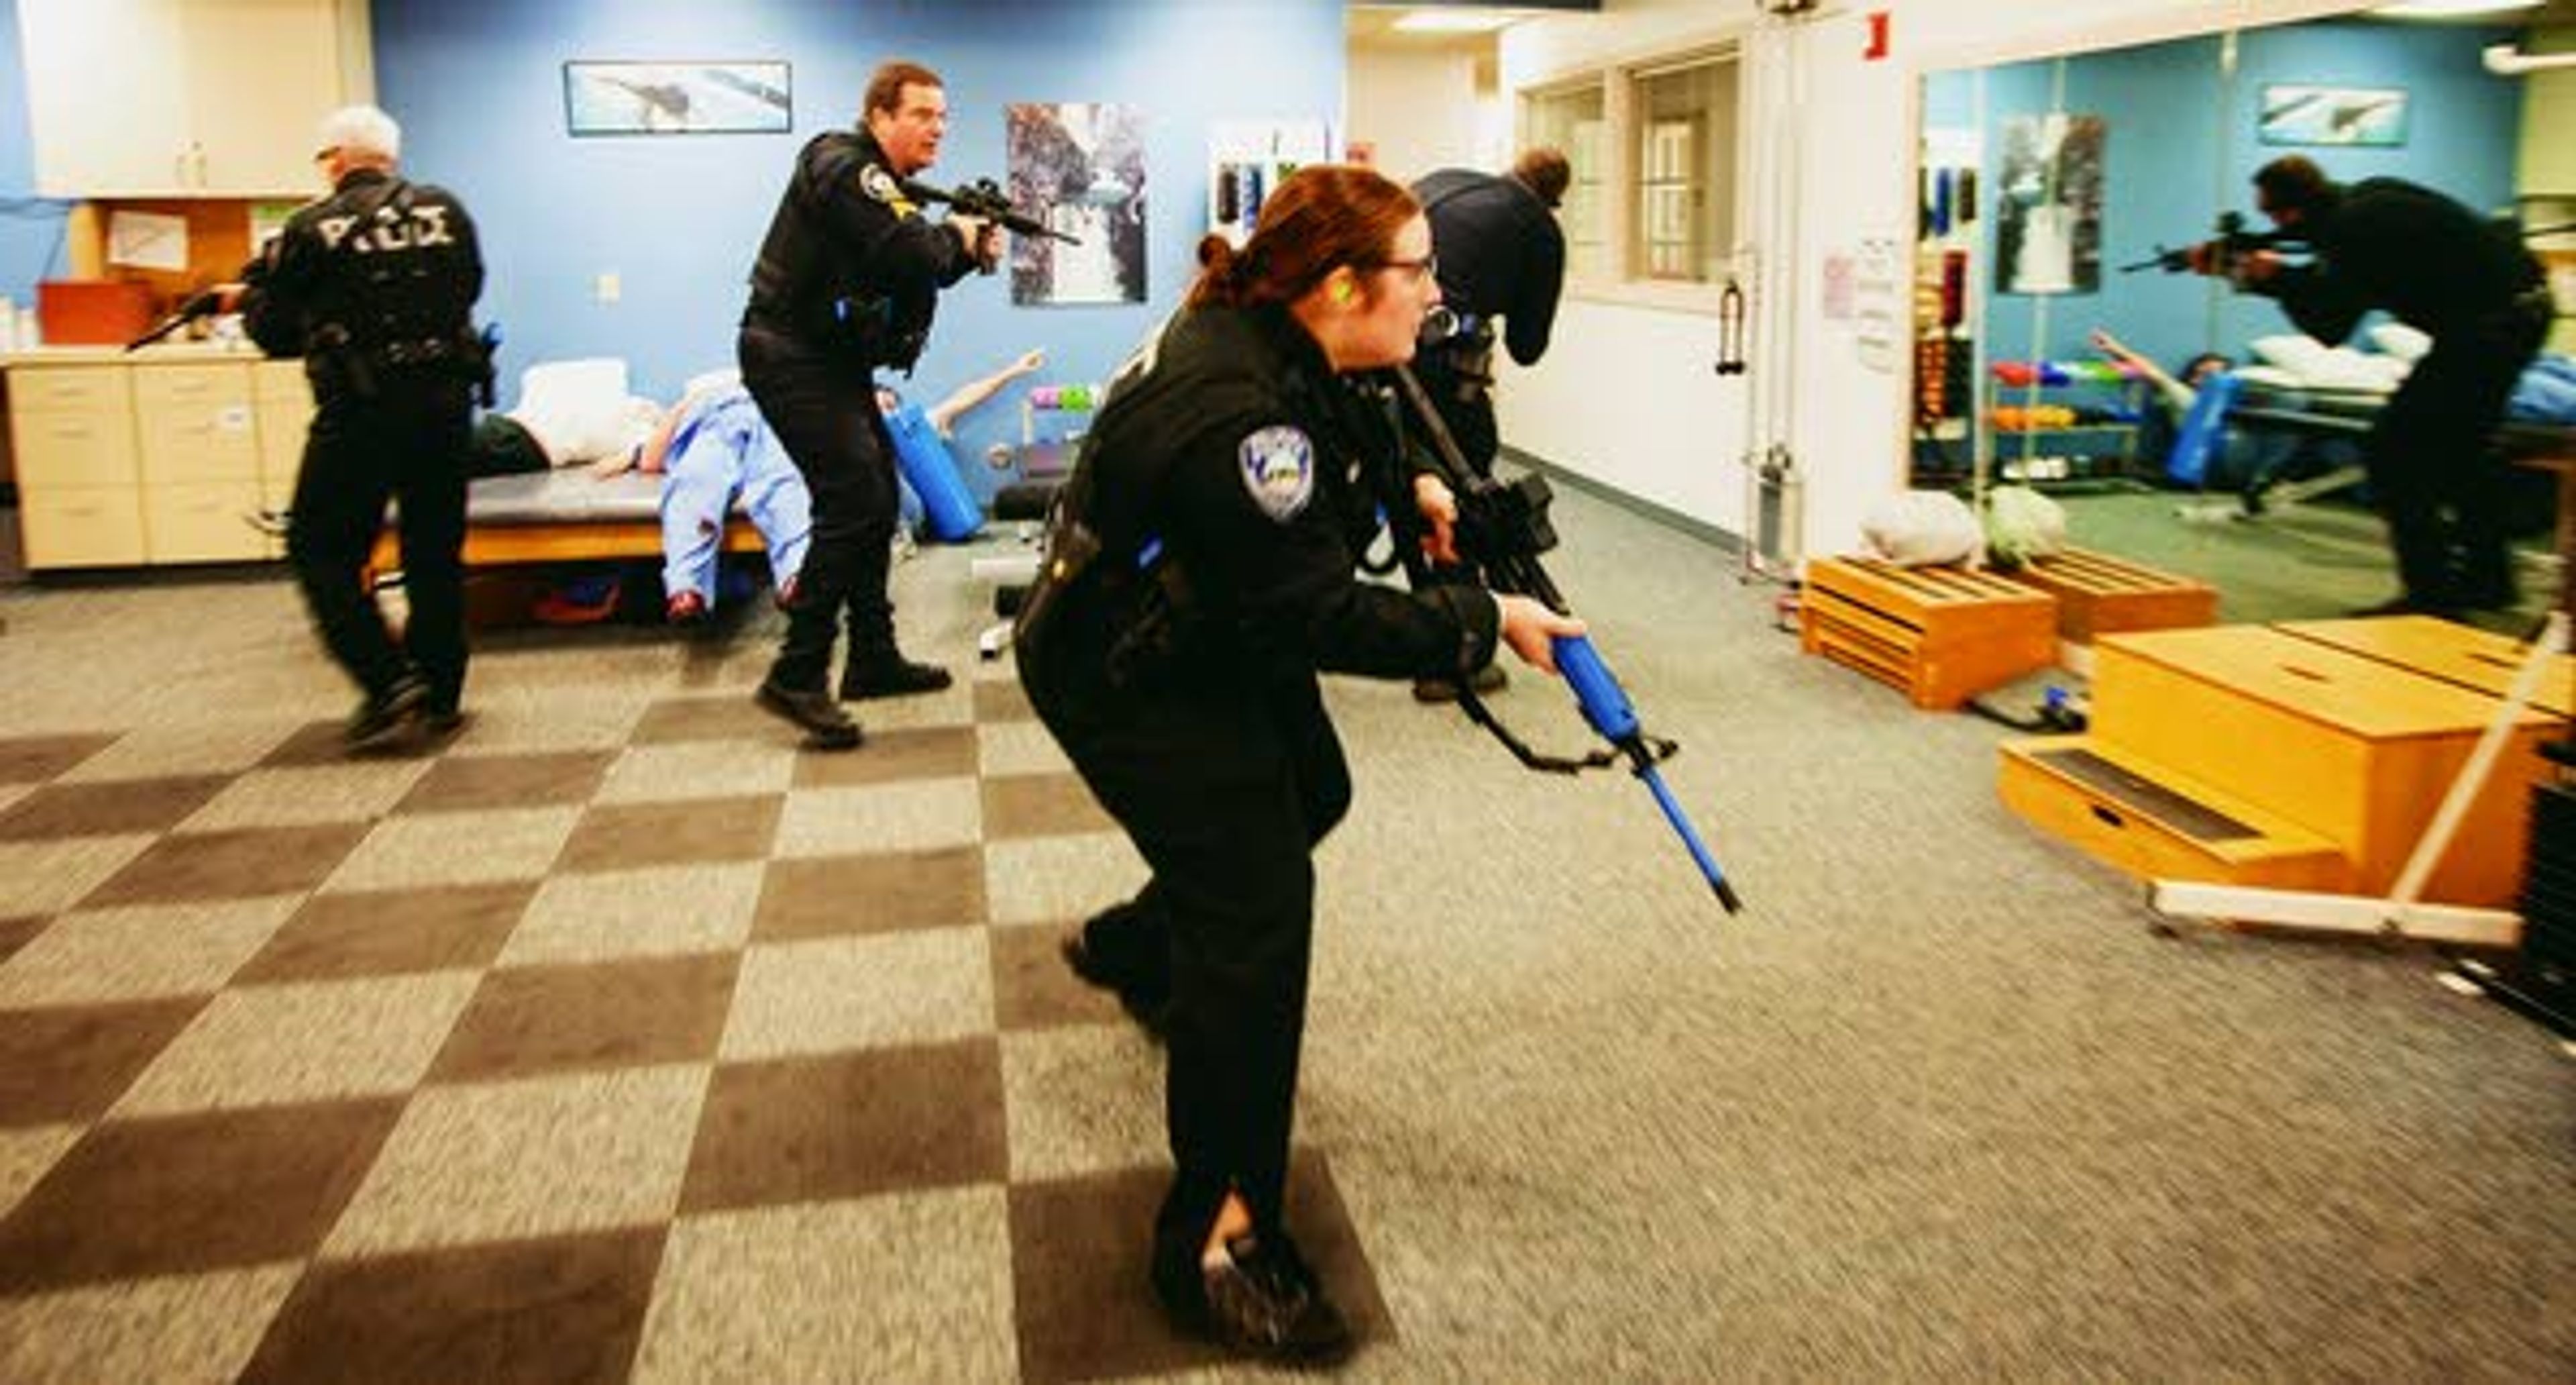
left=1976, top=360, right=2153, bottom=481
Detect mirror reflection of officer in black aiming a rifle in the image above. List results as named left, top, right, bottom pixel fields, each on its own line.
left=2192, top=154, right=2553, bottom=615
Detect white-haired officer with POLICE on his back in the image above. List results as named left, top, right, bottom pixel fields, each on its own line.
left=224, top=105, right=490, bottom=747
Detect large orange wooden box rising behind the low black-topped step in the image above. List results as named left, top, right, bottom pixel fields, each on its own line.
left=2092, top=625, right=2563, bottom=906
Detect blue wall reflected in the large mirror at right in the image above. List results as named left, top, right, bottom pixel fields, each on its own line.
left=1924, top=21, right=2522, bottom=380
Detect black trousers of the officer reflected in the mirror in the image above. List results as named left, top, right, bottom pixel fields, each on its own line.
left=2362, top=293, right=2548, bottom=610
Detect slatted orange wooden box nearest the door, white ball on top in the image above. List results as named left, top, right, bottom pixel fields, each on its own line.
left=1798, top=559, right=2058, bottom=711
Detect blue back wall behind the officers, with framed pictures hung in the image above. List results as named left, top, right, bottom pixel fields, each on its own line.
left=376, top=0, right=1342, bottom=468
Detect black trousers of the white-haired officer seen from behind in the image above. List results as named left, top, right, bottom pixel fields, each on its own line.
left=286, top=376, right=474, bottom=711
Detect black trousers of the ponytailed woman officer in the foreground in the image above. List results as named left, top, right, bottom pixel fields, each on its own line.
left=1022, top=641, right=1350, bottom=1256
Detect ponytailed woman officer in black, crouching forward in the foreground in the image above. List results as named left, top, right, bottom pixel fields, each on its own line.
left=1015, top=165, right=1582, bottom=1362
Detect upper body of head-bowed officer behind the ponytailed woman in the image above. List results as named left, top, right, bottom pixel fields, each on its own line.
left=1414, top=147, right=1571, bottom=476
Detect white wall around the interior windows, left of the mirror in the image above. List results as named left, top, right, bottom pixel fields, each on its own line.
left=1497, top=0, right=2362, bottom=556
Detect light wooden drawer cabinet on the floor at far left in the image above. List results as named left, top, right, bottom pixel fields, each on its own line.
left=10, top=353, right=312, bottom=569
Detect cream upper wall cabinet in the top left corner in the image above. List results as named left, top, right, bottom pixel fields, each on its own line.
left=18, top=0, right=368, bottom=198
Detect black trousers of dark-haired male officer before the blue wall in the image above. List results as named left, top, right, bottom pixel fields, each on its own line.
left=737, top=327, right=896, bottom=690
